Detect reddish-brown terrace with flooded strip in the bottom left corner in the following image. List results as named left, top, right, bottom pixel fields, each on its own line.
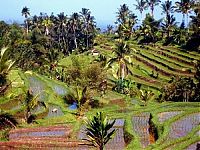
left=0, top=125, right=93, bottom=150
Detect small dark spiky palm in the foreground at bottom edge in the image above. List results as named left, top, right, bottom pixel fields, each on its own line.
left=85, top=112, right=116, bottom=150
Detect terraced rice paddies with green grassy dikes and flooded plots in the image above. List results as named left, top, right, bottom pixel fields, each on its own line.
left=0, top=38, right=200, bottom=150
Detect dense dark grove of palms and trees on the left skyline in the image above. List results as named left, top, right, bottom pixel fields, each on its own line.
left=0, top=7, right=97, bottom=69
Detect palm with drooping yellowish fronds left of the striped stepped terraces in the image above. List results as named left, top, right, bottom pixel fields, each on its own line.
left=108, top=41, right=132, bottom=81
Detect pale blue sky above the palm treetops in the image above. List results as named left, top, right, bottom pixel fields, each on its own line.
left=0, top=0, right=182, bottom=28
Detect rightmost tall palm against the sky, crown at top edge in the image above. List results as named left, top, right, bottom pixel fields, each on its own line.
left=175, top=0, right=194, bottom=26
